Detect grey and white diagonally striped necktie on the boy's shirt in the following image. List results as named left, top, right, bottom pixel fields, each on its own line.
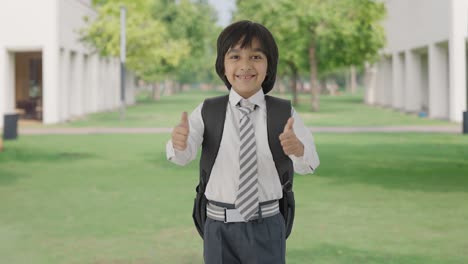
left=235, top=99, right=258, bottom=221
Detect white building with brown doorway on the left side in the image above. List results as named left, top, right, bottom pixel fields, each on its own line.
left=0, top=0, right=134, bottom=127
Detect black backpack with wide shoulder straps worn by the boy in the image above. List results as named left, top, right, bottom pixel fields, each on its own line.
left=192, top=95, right=295, bottom=239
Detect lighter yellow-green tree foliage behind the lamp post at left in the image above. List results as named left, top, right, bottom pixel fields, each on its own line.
left=82, top=0, right=190, bottom=81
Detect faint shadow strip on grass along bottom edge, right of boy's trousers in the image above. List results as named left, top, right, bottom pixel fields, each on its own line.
left=287, top=244, right=461, bottom=264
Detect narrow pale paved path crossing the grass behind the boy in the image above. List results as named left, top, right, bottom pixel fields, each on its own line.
left=19, top=125, right=462, bottom=135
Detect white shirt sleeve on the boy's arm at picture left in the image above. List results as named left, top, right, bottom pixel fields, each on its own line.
left=166, top=103, right=205, bottom=166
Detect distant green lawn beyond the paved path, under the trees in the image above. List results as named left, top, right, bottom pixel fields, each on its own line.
left=31, top=90, right=457, bottom=127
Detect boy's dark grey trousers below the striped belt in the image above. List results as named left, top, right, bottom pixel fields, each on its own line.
left=203, top=213, right=286, bottom=264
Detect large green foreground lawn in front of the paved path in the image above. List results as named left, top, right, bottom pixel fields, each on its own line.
left=0, top=134, right=468, bottom=264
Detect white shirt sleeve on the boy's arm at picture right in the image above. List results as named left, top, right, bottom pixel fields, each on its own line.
left=289, top=108, right=320, bottom=174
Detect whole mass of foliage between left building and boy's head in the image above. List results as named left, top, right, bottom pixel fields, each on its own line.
left=81, top=0, right=218, bottom=82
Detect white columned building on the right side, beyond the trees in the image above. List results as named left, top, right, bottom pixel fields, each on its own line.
left=366, top=0, right=468, bottom=122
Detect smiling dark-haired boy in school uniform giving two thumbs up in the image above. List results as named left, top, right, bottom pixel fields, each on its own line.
left=166, top=21, right=319, bottom=264
